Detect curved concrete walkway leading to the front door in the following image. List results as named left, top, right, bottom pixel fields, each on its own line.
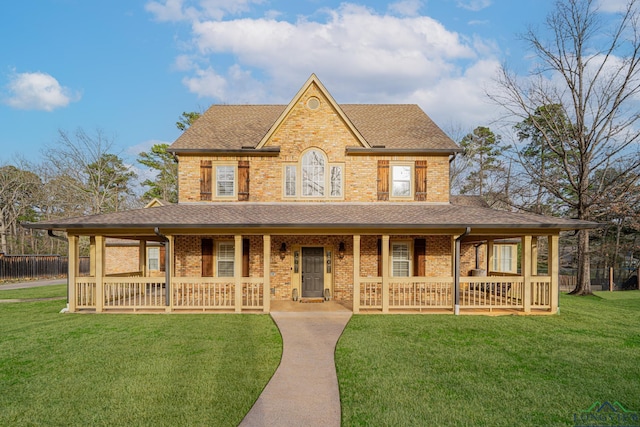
left=240, top=310, right=351, bottom=427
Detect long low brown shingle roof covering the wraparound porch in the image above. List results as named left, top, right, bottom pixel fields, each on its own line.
left=24, top=202, right=597, bottom=233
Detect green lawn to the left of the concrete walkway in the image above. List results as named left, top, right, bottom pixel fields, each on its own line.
left=0, top=300, right=282, bottom=426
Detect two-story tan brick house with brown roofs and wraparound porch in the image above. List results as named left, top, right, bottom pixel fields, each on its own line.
left=28, top=75, right=595, bottom=313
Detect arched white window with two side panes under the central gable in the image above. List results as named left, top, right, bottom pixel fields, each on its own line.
left=283, top=149, right=344, bottom=198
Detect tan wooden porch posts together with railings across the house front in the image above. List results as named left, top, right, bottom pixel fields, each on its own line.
left=62, top=234, right=558, bottom=313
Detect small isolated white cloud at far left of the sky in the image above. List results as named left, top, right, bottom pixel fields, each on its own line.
left=4, top=72, right=80, bottom=111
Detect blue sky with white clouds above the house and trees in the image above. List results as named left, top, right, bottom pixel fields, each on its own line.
left=0, top=0, right=620, bottom=164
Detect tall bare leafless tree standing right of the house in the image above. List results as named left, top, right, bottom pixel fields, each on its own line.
left=489, top=0, right=640, bottom=295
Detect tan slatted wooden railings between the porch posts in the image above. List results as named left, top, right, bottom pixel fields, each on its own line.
left=70, top=276, right=557, bottom=312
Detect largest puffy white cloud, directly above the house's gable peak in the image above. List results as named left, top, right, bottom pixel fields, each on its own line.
left=187, top=5, right=475, bottom=102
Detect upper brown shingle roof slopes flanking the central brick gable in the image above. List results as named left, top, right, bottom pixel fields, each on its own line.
left=169, top=104, right=460, bottom=152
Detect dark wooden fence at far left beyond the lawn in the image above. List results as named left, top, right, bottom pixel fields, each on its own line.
left=0, top=253, right=89, bottom=280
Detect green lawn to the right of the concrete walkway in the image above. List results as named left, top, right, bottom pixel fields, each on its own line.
left=336, top=291, right=640, bottom=426
